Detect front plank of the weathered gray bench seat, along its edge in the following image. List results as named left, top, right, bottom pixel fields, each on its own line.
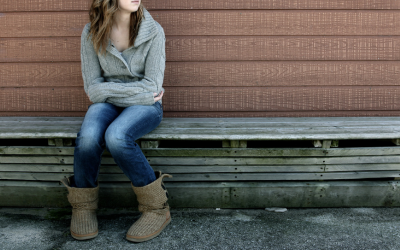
left=0, top=126, right=400, bottom=140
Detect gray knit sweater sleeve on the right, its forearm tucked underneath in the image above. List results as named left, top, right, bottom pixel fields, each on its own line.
left=107, top=25, right=166, bottom=107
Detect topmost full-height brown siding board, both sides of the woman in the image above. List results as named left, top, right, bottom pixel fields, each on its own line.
left=0, top=10, right=400, bottom=37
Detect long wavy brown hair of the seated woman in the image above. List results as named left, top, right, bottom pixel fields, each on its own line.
left=88, top=0, right=144, bottom=54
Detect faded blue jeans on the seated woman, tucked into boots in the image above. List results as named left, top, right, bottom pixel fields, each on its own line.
left=71, top=102, right=163, bottom=188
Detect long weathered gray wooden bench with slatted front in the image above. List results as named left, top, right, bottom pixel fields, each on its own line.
left=0, top=117, right=400, bottom=208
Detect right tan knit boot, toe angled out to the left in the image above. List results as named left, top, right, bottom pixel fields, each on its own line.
left=126, top=171, right=172, bottom=242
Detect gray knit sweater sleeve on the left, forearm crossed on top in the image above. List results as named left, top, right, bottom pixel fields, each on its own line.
left=81, top=24, right=162, bottom=106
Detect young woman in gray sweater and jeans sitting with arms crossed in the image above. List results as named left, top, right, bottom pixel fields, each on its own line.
left=61, top=0, right=171, bottom=242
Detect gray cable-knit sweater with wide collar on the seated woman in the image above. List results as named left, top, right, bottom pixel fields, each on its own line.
left=81, top=9, right=165, bottom=107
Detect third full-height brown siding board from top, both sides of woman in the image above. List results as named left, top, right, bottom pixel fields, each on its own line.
left=0, top=61, right=400, bottom=87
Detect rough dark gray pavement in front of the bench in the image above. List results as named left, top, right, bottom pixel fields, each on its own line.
left=0, top=208, right=400, bottom=250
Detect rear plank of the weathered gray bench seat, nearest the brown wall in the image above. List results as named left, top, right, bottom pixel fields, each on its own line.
left=4, top=117, right=400, bottom=128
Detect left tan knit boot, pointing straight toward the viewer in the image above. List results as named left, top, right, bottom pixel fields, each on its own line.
left=61, top=177, right=99, bottom=240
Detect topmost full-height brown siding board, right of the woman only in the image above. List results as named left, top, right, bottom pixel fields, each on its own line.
left=152, top=10, right=400, bottom=36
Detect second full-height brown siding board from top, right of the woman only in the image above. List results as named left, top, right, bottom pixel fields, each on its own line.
left=166, top=36, right=400, bottom=61
